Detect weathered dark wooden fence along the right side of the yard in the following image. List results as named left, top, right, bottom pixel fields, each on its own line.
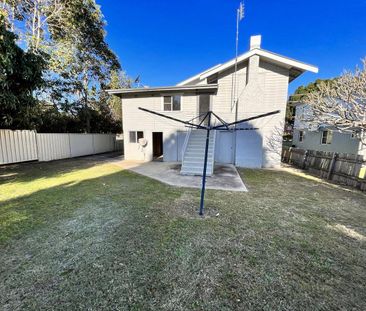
left=282, top=148, right=366, bottom=191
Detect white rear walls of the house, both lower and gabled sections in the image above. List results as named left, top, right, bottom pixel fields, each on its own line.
left=122, top=56, right=289, bottom=167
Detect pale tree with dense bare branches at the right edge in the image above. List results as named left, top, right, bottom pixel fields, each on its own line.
left=301, top=59, right=366, bottom=144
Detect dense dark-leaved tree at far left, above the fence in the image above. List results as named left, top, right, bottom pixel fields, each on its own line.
left=0, top=17, right=46, bottom=129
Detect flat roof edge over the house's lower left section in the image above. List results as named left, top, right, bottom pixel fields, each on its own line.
left=106, top=84, right=217, bottom=97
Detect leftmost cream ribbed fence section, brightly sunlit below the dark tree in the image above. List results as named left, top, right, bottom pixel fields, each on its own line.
left=0, top=130, right=38, bottom=164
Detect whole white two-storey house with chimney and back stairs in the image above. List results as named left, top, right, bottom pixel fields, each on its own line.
left=108, top=36, right=318, bottom=175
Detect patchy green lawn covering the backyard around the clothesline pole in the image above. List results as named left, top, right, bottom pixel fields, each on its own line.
left=0, top=158, right=366, bottom=311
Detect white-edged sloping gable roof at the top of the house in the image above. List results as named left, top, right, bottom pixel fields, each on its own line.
left=177, top=48, right=318, bottom=86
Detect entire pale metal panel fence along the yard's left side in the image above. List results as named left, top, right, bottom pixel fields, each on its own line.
left=0, top=130, right=117, bottom=165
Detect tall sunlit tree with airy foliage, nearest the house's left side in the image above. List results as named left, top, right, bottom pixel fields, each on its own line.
left=45, top=0, right=120, bottom=132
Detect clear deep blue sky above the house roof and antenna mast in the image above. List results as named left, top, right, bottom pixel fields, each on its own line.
left=97, top=0, right=366, bottom=93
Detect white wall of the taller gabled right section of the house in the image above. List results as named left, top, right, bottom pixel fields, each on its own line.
left=213, top=56, right=289, bottom=167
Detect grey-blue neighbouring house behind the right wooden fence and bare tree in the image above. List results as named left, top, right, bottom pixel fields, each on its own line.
left=292, top=103, right=366, bottom=157
